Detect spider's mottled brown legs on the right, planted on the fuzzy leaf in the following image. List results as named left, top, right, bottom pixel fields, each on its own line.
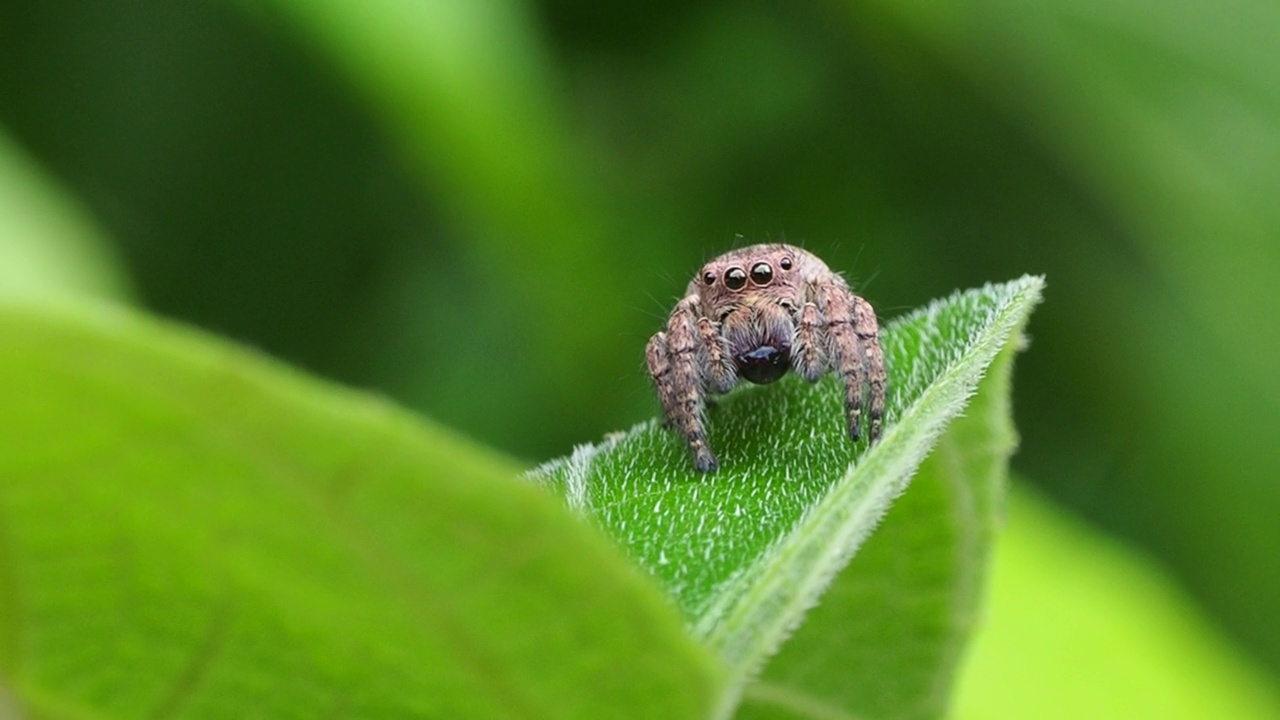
left=815, top=282, right=884, bottom=442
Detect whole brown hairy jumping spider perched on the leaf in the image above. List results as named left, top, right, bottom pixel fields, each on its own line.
left=645, top=245, right=884, bottom=473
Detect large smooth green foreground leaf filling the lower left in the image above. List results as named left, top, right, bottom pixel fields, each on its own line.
left=0, top=304, right=722, bottom=719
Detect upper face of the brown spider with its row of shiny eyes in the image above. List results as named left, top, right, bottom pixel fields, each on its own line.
left=689, top=245, right=812, bottom=320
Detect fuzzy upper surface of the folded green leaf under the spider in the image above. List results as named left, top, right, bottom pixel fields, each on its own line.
left=535, top=277, right=1043, bottom=707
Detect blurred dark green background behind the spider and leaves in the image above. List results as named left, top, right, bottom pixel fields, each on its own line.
left=0, top=0, right=1280, bottom=707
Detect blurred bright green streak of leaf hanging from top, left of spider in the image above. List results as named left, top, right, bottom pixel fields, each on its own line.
left=243, top=0, right=614, bottom=333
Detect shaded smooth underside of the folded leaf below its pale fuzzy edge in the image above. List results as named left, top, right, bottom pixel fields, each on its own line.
left=737, top=297, right=1020, bottom=720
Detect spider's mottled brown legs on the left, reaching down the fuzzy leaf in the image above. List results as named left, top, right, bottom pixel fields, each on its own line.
left=645, top=296, right=732, bottom=473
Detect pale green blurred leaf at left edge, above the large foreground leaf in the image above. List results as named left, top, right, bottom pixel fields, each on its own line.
left=0, top=132, right=128, bottom=300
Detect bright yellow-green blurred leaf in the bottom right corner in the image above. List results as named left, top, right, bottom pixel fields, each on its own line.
left=954, top=487, right=1280, bottom=720
